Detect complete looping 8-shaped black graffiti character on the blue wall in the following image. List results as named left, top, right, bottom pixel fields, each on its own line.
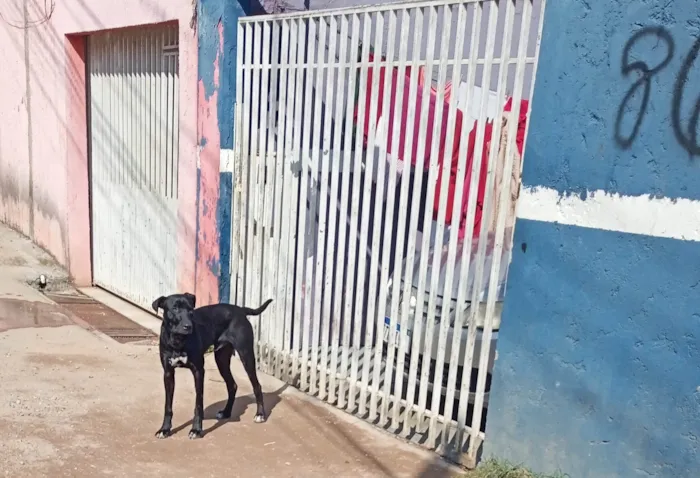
left=615, top=27, right=676, bottom=149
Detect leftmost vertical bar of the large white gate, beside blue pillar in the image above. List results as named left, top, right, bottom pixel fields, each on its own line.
left=230, top=23, right=245, bottom=304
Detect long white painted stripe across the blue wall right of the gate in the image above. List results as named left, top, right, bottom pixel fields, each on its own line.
left=517, top=187, right=700, bottom=241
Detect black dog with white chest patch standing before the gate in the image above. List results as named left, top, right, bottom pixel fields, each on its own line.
left=153, top=294, right=272, bottom=438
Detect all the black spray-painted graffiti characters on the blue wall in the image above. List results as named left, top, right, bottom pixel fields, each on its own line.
left=615, top=26, right=700, bottom=156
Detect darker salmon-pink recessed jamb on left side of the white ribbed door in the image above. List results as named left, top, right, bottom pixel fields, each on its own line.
left=65, top=35, right=92, bottom=286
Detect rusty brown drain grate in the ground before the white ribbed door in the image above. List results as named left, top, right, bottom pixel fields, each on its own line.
left=45, top=293, right=157, bottom=344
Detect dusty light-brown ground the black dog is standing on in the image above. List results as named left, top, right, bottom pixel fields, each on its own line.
left=0, top=298, right=459, bottom=477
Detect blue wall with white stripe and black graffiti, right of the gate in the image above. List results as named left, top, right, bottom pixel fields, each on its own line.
left=486, top=0, right=700, bottom=478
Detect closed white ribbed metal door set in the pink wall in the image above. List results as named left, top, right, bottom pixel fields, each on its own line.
left=88, top=25, right=179, bottom=307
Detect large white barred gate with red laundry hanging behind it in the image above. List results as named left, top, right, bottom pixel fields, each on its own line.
left=231, top=0, right=544, bottom=466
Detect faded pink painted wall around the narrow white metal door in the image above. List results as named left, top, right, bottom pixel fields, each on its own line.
left=0, top=0, right=202, bottom=291
